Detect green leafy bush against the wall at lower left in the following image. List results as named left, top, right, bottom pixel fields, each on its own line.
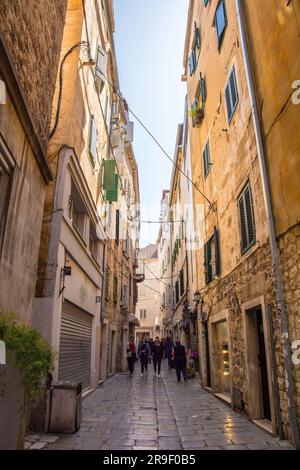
left=0, top=311, right=55, bottom=403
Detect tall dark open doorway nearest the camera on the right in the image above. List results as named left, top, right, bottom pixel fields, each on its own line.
left=246, top=307, right=271, bottom=421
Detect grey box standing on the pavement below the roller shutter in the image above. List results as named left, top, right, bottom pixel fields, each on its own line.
left=49, top=382, right=82, bottom=433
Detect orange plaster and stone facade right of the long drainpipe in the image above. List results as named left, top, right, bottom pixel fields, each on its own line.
left=242, top=0, right=300, bottom=446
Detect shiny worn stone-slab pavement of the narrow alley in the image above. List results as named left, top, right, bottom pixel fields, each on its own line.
left=26, top=363, right=292, bottom=450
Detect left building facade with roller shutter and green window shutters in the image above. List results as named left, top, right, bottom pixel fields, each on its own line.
left=31, top=0, right=139, bottom=431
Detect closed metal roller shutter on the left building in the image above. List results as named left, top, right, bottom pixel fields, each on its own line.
left=58, top=301, right=92, bottom=388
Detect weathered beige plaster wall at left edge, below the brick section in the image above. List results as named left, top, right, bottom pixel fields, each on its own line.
left=0, top=94, right=45, bottom=324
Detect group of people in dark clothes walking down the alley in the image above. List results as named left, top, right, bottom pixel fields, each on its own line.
left=127, top=336, right=187, bottom=382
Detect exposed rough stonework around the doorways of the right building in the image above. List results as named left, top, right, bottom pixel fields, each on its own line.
left=199, top=243, right=292, bottom=438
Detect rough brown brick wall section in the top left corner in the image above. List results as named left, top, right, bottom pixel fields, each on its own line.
left=0, top=0, right=67, bottom=150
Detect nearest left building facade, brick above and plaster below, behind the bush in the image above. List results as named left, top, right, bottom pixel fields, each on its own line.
left=0, top=0, right=66, bottom=449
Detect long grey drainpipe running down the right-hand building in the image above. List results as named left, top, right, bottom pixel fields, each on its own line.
left=236, top=0, right=300, bottom=449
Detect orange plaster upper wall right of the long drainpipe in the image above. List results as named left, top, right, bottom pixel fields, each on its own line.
left=243, top=0, right=300, bottom=235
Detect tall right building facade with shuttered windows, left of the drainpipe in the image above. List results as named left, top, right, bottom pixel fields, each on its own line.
left=183, top=0, right=288, bottom=435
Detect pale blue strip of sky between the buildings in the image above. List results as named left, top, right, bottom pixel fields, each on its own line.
left=114, top=0, right=188, bottom=247
